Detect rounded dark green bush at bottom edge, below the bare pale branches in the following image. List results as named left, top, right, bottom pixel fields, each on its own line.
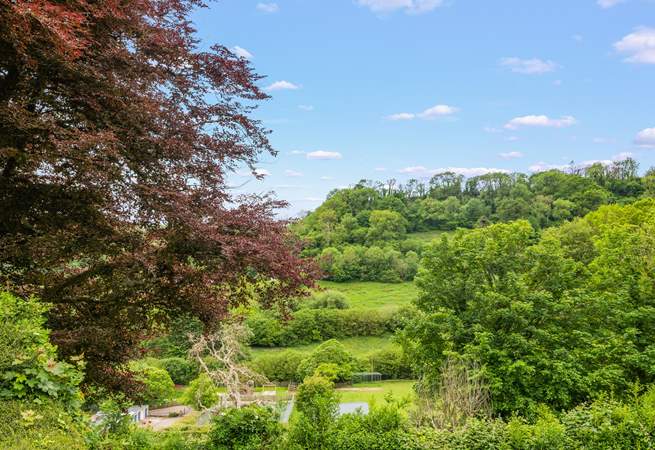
left=209, top=405, right=282, bottom=450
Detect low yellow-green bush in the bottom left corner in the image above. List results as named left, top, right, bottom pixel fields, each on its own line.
left=0, top=399, right=89, bottom=450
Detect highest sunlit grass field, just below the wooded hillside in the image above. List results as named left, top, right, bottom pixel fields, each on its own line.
left=319, top=281, right=417, bottom=310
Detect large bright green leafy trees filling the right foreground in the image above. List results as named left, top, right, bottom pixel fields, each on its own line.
left=408, top=200, right=655, bottom=414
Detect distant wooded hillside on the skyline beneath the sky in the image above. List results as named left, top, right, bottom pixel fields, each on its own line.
left=294, top=159, right=655, bottom=282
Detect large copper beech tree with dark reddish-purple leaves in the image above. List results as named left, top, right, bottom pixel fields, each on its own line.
left=0, top=0, right=314, bottom=385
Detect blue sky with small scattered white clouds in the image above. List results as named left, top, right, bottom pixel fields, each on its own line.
left=193, top=0, right=655, bottom=215
